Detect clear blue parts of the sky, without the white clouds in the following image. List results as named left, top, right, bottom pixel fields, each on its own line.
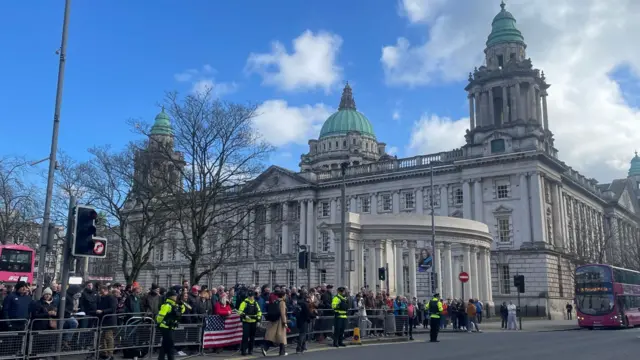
left=0, top=0, right=465, bottom=172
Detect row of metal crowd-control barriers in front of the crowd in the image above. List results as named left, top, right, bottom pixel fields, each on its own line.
left=0, top=309, right=409, bottom=360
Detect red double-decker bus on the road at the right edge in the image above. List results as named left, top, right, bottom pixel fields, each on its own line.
left=575, top=264, right=640, bottom=329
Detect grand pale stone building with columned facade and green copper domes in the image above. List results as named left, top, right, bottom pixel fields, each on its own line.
left=131, top=4, right=640, bottom=317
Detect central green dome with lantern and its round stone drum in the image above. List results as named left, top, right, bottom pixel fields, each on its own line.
left=300, top=82, right=389, bottom=171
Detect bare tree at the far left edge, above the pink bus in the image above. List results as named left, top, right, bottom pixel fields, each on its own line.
left=0, top=157, right=42, bottom=245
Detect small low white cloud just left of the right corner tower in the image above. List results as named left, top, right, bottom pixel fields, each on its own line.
left=407, top=114, right=469, bottom=155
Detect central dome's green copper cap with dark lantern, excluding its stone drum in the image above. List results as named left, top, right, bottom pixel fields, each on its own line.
left=320, top=83, right=376, bottom=139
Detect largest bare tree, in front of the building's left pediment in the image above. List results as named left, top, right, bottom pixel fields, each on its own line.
left=138, top=91, right=273, bottom=284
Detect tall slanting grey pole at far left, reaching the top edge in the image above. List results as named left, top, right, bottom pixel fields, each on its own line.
left=36, top=0, right=71, bottom=299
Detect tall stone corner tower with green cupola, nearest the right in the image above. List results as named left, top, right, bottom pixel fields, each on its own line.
left=465, top=1, right=557, bottom=157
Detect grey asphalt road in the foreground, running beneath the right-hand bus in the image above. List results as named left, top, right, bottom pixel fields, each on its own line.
left=217, top=324, right=640, bottom=360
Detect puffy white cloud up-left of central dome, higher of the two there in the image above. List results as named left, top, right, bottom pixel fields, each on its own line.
left=246, top=30, right=342, bottom=92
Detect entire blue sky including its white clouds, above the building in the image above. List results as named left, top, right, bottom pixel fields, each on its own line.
left=0, top=0, right=640, bottom=181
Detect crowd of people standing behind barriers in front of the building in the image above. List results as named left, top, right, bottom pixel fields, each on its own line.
left=2, top=280, right=515, bottom=359
